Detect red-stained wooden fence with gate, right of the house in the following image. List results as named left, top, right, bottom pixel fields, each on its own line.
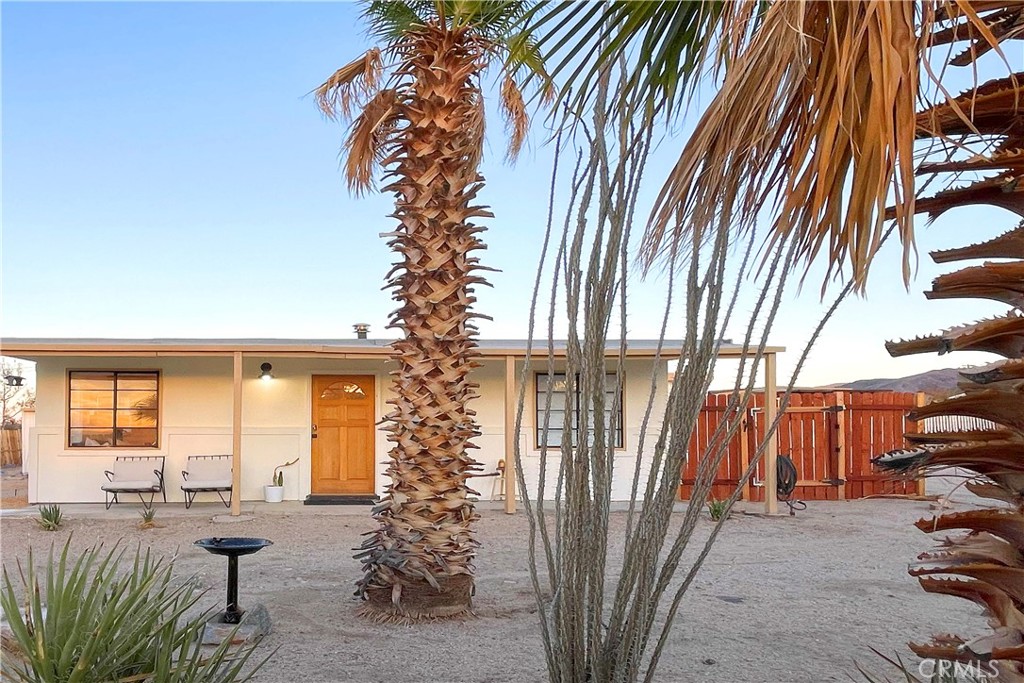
left=679, top=391, right=924, bottom=501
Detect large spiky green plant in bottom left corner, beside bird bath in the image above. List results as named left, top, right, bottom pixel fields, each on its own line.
left=0, top=540, right=269, bottom=683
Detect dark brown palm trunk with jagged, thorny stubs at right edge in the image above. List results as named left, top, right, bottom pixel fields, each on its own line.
left=876, top=3, right=1024, bottom=681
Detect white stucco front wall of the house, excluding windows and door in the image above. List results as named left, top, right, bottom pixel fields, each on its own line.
left=28, top=356, right=666, bottom=503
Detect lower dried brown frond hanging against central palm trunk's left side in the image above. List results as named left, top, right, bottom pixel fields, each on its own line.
left=343, top=88, right=398, bottom=196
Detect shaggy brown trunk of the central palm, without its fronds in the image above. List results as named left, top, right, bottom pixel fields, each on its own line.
left=359, top=26, right=490, bottom=620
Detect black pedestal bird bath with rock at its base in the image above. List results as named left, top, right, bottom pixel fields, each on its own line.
left=195, top=538, right=273, bottom=645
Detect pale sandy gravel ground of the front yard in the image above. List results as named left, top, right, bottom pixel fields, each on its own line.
left=0, top=500, right=985, bottom=683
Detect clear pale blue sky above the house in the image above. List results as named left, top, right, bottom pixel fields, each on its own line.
left=0, top=2, right=1014, bottom=384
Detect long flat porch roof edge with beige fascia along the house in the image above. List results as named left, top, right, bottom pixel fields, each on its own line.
left=0, top=337, right=785, bottom=360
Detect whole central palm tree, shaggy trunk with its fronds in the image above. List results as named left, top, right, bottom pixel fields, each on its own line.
left=315, top=0, right=540, bottom=620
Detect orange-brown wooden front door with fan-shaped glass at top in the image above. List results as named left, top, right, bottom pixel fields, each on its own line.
left=311, top=375, right=375, bottom=495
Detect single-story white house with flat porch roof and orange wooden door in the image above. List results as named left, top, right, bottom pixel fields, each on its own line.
left=0, top=338, right=782, bottom=513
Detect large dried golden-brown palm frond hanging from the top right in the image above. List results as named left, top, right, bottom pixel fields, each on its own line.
left=643, top=0, right=930, bottom=287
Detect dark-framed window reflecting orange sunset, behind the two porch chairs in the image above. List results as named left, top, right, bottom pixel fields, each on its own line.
left=68, top=370, right=160, bottom=449
